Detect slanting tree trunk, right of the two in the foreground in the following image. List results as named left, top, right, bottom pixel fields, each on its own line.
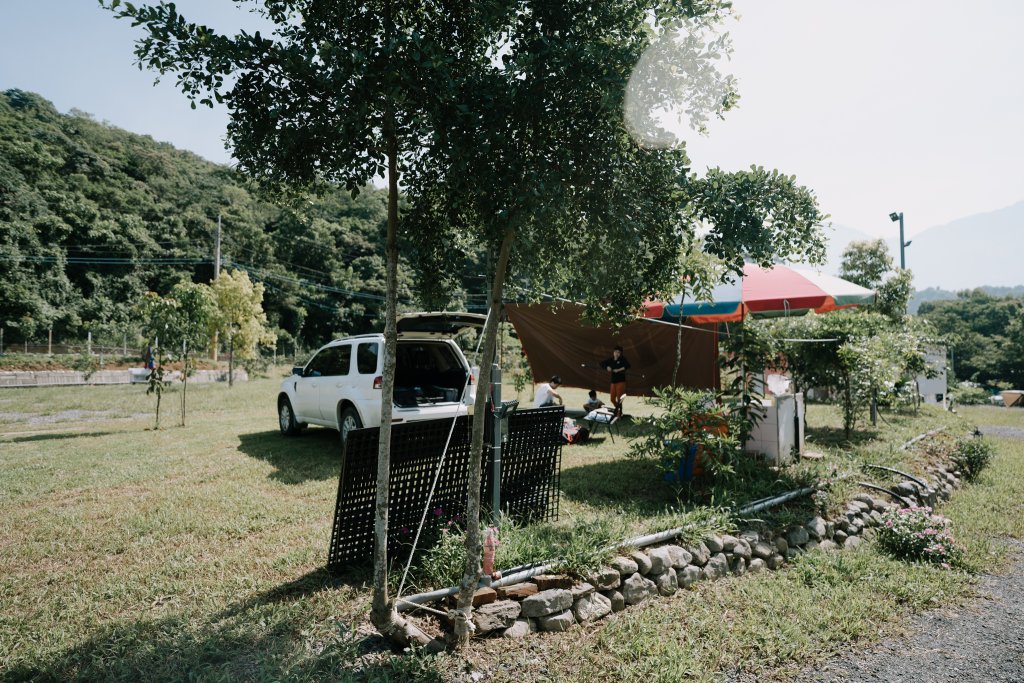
left=451, top=227, right=515, bottom=647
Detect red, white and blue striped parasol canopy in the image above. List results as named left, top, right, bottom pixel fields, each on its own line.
left=643, top=263, right=874, bottom=324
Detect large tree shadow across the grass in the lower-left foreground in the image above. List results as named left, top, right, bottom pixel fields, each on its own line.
left=0, top=570, right=444, bottom=682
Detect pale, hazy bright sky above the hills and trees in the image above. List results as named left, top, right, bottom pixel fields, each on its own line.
left=0, top=0, right=1024, bottom=238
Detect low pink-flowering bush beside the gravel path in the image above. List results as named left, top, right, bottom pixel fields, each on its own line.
left=877, top=507, right=964, bottom=569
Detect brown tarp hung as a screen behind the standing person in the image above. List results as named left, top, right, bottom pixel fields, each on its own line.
left=505, top=303, right=719, bottom=396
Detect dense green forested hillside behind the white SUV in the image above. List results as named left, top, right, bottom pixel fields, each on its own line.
left=0, top=90, right=460, bottom=347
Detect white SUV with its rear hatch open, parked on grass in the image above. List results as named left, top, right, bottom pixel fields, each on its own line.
left=278, top=313, right=486, bottom=440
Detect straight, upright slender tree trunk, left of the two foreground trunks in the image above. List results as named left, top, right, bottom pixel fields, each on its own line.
left=370, top=108, right=430, bottom=647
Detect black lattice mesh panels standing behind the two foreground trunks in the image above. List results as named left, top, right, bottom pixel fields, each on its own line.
left=328, top=407, right=563, bottom=569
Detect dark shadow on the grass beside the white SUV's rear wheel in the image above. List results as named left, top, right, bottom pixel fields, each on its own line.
left=239, top=429, right=341, bottom=483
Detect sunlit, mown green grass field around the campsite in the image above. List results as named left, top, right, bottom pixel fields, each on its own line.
left=0, top=379, right=1024, bottom=681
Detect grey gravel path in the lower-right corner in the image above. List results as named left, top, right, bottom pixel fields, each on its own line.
left=800, top=427, right=1024, bottom=683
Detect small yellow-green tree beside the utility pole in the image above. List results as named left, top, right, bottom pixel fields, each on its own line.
left=210, top=270, right=276, bottom=386
